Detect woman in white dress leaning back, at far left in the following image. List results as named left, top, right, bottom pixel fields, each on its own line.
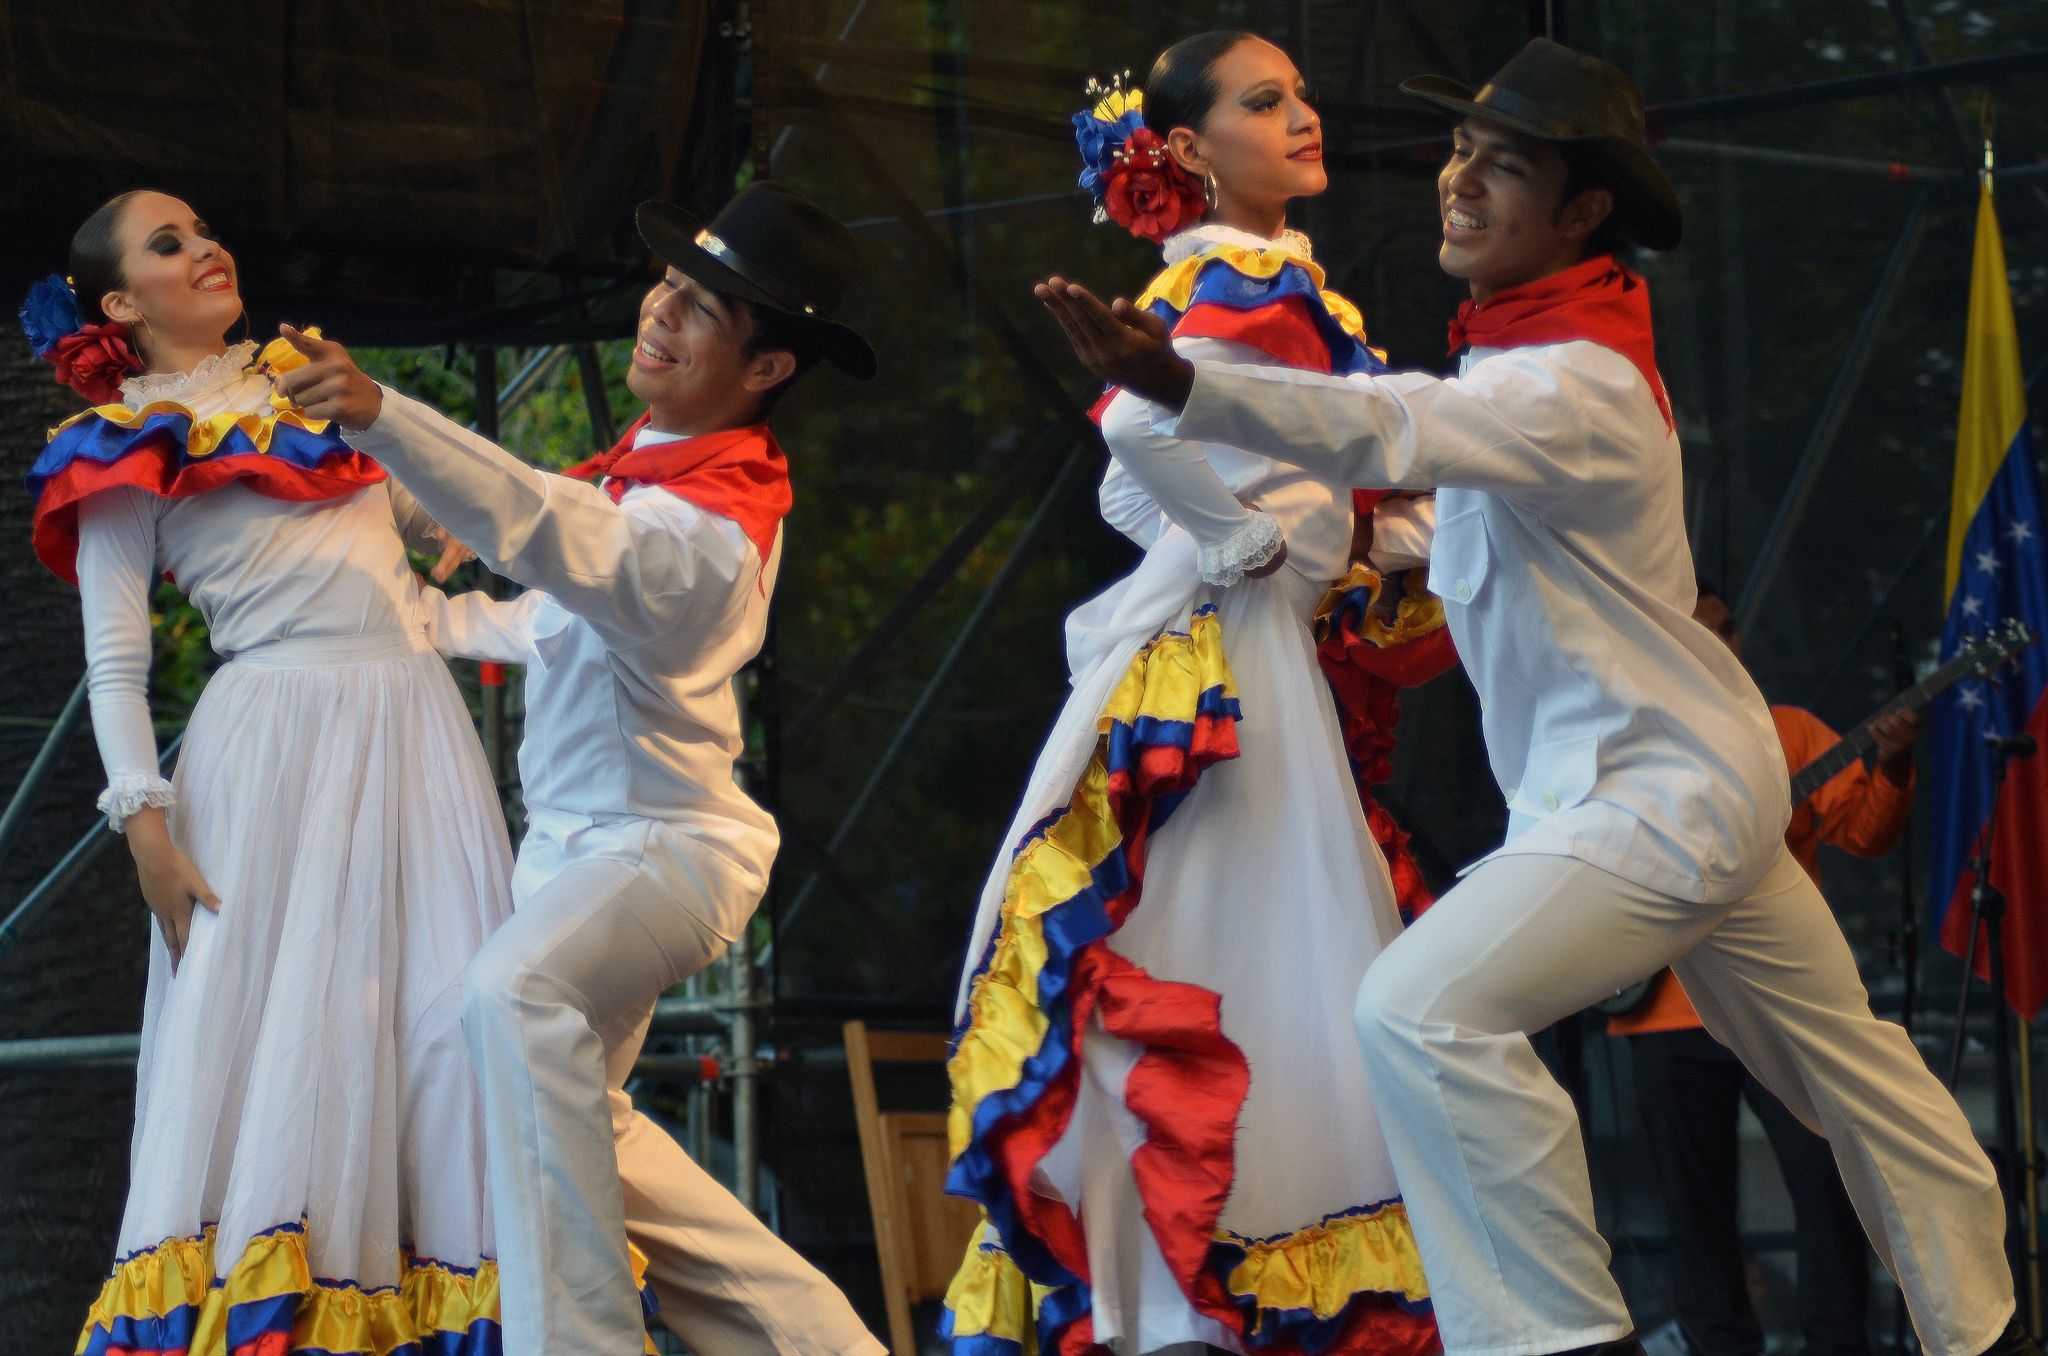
left=23, top=193, right=510, bottom=1356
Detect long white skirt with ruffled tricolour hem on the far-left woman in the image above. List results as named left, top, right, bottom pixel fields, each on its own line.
left=80, top=631, right=512, bottom=1354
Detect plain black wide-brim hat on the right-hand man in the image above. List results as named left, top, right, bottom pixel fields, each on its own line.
left=1401, top=37, right=1686, bottom=250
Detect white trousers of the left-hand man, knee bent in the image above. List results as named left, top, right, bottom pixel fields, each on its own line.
left=463, top=813, right=885, bottom=1356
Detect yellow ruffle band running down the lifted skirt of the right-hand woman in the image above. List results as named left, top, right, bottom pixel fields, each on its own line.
left=946, top=612, right=1237, bottom=1157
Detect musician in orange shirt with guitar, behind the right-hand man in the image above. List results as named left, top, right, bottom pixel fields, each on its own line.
left=1608, top=580, right=1919, bottom=1356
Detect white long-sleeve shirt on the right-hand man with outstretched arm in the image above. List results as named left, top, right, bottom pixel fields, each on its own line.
left=1153, top=340, right=1790, bottom=901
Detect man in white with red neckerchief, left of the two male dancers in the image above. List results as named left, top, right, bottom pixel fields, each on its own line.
left=279, top=182, right=883, bottom=1356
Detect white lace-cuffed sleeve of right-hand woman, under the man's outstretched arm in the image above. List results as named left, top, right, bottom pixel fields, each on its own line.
left=1102, top=338, right=1284, bottom=584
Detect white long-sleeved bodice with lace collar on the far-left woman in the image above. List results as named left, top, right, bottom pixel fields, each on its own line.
left=78, top=344, right=438, bottom=830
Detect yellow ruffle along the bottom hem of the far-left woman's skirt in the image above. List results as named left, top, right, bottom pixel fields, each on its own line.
left=76, top=1225, right=500, bottom=1356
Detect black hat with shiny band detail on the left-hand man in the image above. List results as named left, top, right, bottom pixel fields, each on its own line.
left=633, top=178, right=874, bottom=381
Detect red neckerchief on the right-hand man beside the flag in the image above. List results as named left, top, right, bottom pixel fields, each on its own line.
left=1450, top=256, right=1675, bottom=428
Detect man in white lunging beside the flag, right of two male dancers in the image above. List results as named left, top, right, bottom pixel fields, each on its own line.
left=1038, top=39, right=2036, bottom=1356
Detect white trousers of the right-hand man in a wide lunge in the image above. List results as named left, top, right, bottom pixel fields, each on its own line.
left=1356, top=852, right=2013, bottom=1356
